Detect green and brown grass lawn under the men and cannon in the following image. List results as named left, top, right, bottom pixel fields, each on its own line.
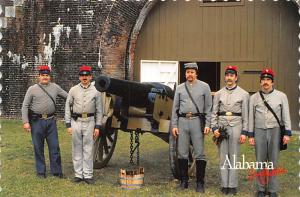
left=0, top=120, right=299, bottom=197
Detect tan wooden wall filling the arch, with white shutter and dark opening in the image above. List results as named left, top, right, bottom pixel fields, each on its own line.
left=133, top=0, right=300, bottom=130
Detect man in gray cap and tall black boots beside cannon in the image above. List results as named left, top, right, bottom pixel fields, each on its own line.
left=171, top=63, right=212, bottom=193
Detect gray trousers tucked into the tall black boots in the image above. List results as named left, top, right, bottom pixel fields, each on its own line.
left=178, top=117, right=205, bottom=160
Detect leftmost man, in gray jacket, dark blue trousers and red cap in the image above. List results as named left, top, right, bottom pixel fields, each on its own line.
left=22, top=65, right=68, bottom=178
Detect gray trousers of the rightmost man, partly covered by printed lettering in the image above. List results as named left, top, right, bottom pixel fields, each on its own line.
left=254, top=127, right=280, bottom=192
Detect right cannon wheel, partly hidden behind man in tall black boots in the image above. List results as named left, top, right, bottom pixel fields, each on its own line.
left=169, top=129, right=196, bottom=179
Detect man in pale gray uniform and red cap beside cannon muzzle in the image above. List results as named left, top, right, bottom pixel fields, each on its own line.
left=65, top=66, right=102, bottom=184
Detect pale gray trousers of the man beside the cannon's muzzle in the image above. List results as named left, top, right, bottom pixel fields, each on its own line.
left=71, top=119, right=95, bottom=178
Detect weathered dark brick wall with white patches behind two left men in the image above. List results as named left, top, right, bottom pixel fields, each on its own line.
left=0, top=0, right=147, bottom=117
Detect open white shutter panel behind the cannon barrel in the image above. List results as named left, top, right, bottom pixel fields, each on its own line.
left=141, top=60, right=178, bottom=89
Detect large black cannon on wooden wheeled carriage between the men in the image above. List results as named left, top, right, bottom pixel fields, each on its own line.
left=94, top=75, right=195, bottom=178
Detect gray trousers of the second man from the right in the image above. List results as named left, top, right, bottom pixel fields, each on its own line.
left=218, top=124, right=242, bottom=188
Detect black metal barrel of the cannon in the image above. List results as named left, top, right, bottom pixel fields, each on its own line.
left=95, top=75, right=174, bottom=107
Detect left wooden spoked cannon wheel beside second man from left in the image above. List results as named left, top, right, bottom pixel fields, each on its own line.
left=93, top=93, right=118, bottom=169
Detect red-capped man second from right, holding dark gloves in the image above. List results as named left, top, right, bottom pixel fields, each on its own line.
left=211, top=66, right=249, bottom=195
